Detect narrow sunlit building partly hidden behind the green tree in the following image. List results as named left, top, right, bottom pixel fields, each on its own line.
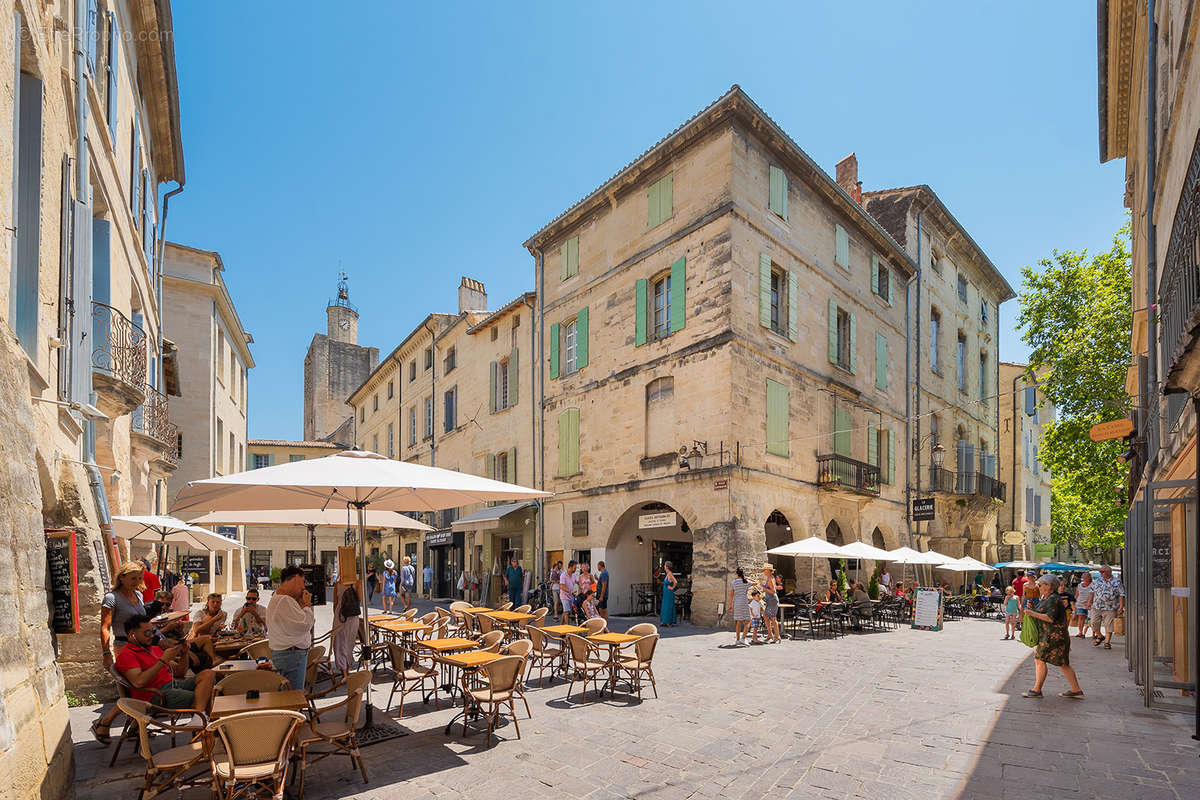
left=998, top=361, right=1051, bottom=561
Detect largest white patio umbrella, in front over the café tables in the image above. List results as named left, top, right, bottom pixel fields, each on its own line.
left=173, top=450, right=551, bottom=724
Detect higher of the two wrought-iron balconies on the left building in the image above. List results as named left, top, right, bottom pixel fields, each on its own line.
left=91, top=302, right=146, bottom=417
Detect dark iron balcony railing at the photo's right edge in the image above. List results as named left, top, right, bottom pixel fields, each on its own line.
left=1152, top=133, right=1200, bottom=389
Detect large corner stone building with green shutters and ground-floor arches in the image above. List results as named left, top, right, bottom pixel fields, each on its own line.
left=526, top=86, right=916, bottom=624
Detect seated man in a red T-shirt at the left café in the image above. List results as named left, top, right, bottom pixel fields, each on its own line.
left=116, top=614, right=214, bottom=711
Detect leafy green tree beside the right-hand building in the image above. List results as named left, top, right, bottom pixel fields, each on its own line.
left=1018, top=223, right=1133, bottom=548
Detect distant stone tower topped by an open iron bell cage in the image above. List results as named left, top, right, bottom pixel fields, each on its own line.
left=304, top=273, right=379, bottom=443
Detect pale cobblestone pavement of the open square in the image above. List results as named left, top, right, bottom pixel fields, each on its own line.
left=72, top=592, right=1200, bottom=800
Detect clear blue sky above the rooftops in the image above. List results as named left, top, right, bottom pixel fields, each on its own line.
left=167, top=0, right=1124, bottom=439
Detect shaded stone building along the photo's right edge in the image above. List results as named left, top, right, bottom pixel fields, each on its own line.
left=1097, top=0, right=1200, bottom=714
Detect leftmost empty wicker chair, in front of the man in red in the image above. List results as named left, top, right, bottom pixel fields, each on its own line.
left=116, top=697, right=212, bottom=800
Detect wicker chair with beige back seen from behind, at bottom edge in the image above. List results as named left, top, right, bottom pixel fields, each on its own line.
left=206, top=711, right=306, bottom=800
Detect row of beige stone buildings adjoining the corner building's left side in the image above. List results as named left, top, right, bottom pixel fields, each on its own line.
left=349, top=277, right=539, bottom=599
